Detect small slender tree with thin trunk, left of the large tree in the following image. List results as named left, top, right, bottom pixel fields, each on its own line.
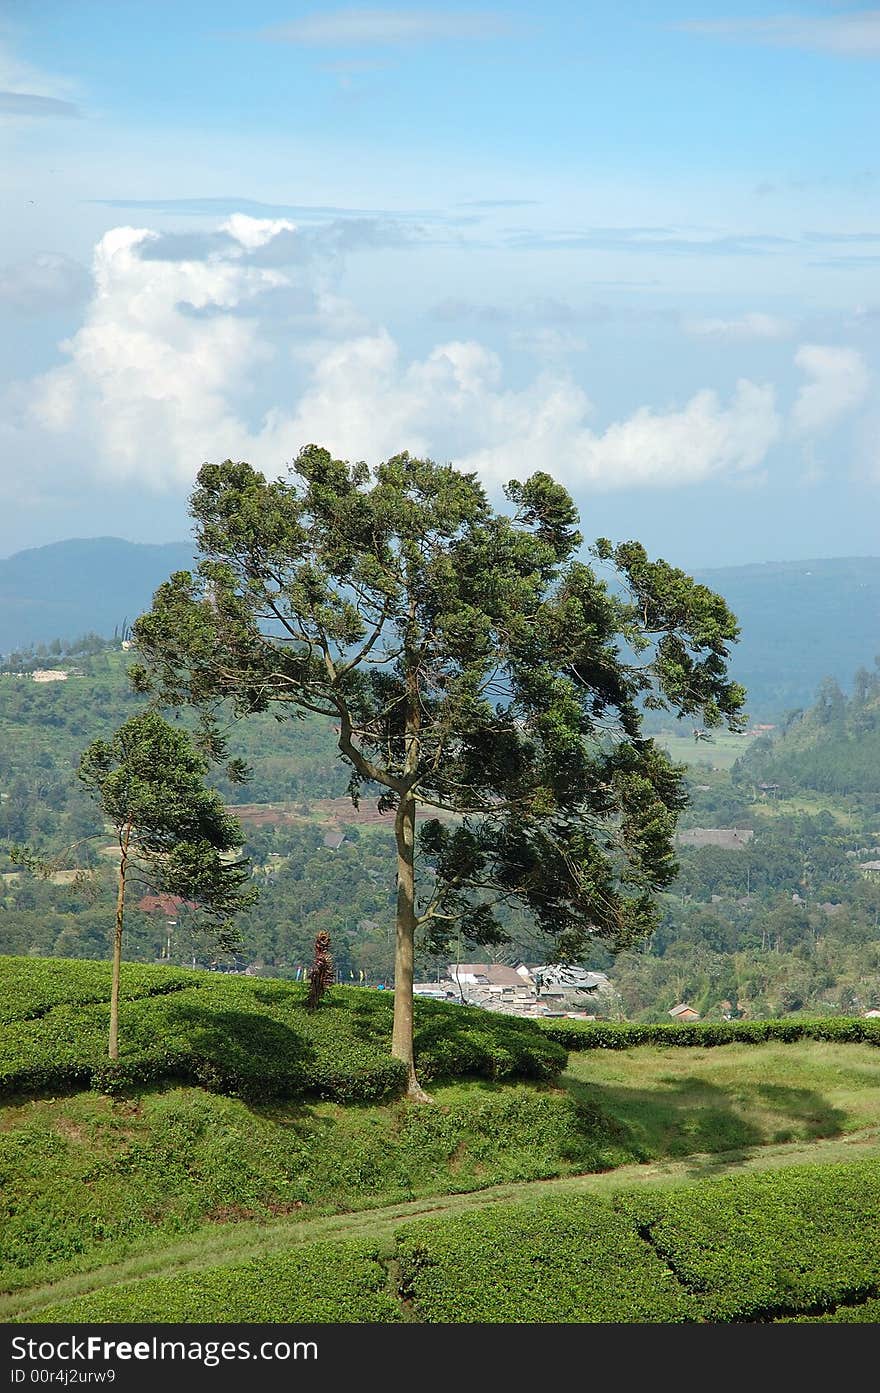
left=78, top=710, right=256, bottom=1059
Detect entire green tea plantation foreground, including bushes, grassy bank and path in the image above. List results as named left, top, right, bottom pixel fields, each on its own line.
left=0, top=958, right=880, bottom=1325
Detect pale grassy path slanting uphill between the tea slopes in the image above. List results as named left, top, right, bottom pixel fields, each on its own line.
left=10, top=1126, right=880, bottom=1321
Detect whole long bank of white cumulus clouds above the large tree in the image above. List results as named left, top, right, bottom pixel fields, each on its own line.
left=4, top=216, right=790, bottom=501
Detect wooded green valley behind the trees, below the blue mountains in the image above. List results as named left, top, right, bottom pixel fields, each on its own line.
left=0, top=641, right=880, bottom=1020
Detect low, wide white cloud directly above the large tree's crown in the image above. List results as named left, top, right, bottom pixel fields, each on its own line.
left=262, top=333, right=780, bottom=490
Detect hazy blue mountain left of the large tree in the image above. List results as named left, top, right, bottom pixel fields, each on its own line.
left=0, top=536, right=194, bottom=653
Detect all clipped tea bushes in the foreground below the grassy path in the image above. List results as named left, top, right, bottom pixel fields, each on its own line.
left=25, top=1162, right=880, bottom=1323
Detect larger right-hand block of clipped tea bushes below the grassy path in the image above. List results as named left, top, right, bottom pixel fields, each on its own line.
left=398, top=1162, right=880, bottom=1323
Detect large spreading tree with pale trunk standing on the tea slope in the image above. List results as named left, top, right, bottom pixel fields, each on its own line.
left=134, top=446, right=745, bottom=1098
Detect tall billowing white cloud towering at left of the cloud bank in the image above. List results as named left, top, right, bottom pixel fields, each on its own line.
left=28, top=227, right=287, bottom=488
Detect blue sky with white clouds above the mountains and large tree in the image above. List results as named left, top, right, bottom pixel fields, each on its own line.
left=0, top=0, right=880, bottom=568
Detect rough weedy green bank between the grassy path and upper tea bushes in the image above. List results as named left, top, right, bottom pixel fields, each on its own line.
left=0, top=1085, right=618, bottom=1291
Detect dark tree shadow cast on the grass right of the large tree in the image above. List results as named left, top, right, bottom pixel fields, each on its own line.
left=567, top=1077, right=847, bottom=1160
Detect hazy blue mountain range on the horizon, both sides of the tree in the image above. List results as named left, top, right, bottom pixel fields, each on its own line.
left=0, top=536, right=880, bottom=720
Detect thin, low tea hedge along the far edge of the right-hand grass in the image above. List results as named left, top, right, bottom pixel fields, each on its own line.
left=540, top=1015, right=880, bottom=1050
